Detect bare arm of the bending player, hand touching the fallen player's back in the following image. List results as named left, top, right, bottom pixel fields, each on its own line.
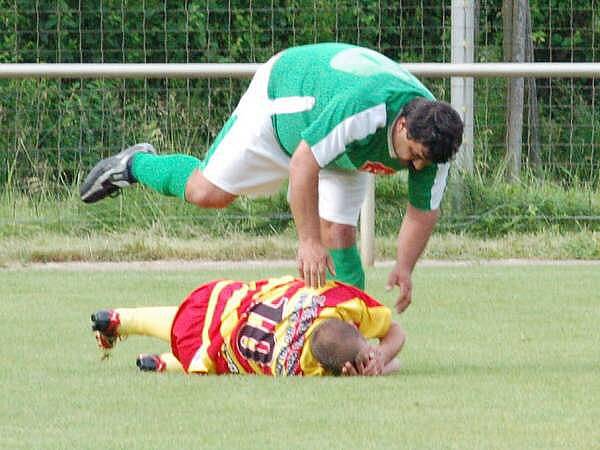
left=290, top=141, right=335, bottom=288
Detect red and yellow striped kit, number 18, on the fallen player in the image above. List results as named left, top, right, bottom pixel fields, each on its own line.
left=171, top=276, right=391, bottom=376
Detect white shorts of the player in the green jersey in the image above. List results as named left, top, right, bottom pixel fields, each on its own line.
left=202, top=55, right=368, bottom=226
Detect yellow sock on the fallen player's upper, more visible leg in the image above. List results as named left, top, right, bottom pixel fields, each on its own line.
left=116, top=306, right=177, bottom=342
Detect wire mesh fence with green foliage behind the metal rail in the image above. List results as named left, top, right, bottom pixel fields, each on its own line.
left=0, top=0, right=600, bottom=234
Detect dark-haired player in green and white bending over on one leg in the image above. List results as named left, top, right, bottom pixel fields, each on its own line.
left=80, top=43, right=463, bottom=312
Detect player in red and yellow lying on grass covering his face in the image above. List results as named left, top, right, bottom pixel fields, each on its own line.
left=92, top=276, right=405, bottom=376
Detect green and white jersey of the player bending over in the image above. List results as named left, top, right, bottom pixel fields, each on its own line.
left=268, top=43, right=448, bottom=210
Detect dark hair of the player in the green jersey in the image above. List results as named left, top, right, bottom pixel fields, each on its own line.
left=400, top=98, right=464, bottom=163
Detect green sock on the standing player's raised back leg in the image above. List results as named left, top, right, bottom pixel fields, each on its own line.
left=131, top=153, right=201, bottom=200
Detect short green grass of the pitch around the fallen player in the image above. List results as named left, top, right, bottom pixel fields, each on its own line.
left=0, top=265, right=600, bottom=449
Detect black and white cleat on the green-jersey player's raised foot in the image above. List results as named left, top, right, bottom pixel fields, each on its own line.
left=79, top=144, right=156, bottom=203
